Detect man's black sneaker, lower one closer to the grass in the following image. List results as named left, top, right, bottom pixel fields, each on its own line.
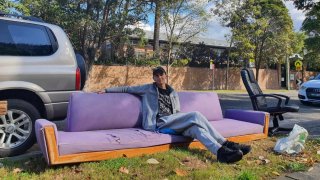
left=217, top=146, right=243, bottom=163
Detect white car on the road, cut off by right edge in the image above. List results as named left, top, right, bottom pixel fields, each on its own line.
left=298, top=74, right=320, bottom=104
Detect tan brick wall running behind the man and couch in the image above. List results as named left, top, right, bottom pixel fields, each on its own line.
left=85, top=65, right=318, bottom=91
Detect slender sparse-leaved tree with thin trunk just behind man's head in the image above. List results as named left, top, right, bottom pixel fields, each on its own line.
left=162, top=0, right=209, bottom=79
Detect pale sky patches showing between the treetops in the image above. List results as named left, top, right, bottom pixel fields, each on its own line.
left=139, top=1, right=305, bottom=40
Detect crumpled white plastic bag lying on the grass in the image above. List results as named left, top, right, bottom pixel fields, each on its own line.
left=274, top=124, right=309, bottom=154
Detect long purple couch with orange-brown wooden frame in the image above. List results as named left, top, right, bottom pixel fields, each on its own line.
left=35, top=92, right=269, bottom=165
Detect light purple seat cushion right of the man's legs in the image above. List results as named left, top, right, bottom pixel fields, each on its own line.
left=210, top=118, right=264, bottom=137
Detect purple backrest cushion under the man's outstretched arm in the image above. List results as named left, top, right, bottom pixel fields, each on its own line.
left=66, top=92, right=141, bottom=132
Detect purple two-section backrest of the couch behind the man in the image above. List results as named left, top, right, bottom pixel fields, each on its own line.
left=66, top=92, right=223, bottom=132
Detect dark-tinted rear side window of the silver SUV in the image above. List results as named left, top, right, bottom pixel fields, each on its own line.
left=0, top=20, right=57, bottom=56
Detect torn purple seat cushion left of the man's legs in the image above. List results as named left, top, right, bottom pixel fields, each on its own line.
left=58, top=128, right=192, bottom=155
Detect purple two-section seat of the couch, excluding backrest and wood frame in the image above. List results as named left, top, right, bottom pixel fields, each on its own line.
left=58, top=119, right=263, bottom=155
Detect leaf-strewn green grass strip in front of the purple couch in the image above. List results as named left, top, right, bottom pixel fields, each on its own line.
left=0, top=137, right=320, bottom=180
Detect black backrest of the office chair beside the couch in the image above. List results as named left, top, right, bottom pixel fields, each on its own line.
left=241, top=69, right=268, bottom=110
